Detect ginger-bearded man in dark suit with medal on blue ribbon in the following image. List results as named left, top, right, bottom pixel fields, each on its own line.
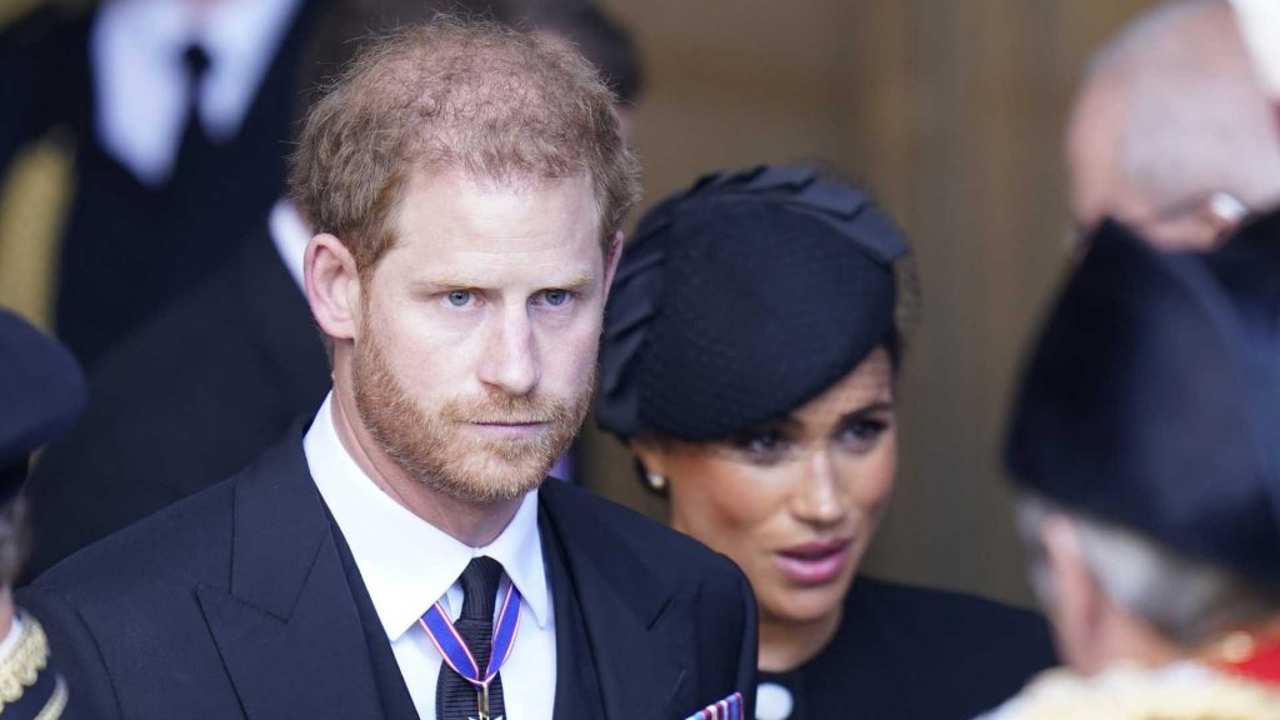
left=24, top=16, right=756, bottom=720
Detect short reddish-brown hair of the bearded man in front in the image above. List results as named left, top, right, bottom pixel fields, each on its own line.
left=289, top=17, right=640, bottom=274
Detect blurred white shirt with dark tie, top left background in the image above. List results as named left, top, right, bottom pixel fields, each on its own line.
left=90, top=0, right=301, bottom=186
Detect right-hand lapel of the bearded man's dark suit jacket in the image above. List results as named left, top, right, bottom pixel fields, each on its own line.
left=539, top=480, right=694, bottom=720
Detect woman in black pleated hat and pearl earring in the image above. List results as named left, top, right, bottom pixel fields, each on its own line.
left=596, top=167, right=1051, bottom=720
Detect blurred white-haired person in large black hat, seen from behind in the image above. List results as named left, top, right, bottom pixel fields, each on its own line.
left=991, top=214, right=1280, bottom=720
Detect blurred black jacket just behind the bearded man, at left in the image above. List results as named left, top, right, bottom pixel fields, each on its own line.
left=27, top=223, right=329, bottom=579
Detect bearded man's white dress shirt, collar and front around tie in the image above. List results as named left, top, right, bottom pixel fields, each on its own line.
left=302, top=393, right=556, bottom=720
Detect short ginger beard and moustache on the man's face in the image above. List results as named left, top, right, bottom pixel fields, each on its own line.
left=352, top=316, right=595, bottom=503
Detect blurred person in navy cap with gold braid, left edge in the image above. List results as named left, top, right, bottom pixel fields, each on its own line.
left=0, top=309, right=92, bottom=720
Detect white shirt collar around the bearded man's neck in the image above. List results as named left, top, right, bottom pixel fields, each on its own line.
left=302, top=392, right=550, bottom=641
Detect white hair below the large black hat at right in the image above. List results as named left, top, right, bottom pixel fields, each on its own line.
left=1016, top=493, right=1280, bottom=647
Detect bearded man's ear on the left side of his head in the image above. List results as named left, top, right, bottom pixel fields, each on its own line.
left=302, top=233, right=362, bottom=340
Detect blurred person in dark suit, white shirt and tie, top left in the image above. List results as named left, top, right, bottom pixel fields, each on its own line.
left=0, top=0, right=324, bottom=369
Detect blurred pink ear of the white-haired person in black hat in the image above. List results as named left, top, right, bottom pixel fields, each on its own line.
left=1041, top=512, right=1106, bottom=673
